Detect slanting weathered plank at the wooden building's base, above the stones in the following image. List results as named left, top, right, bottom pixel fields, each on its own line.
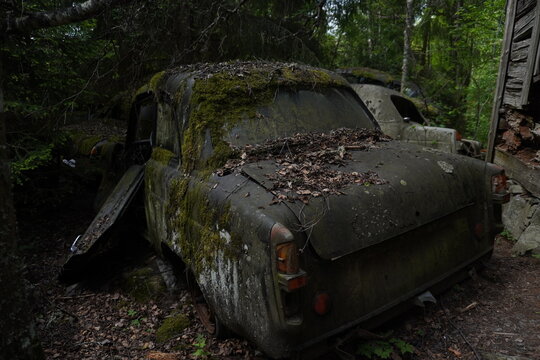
left=495, top=149, right=540, bottom=197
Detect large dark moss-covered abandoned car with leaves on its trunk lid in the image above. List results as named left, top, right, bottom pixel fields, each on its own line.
left=64, top=62, right=506, bottom=358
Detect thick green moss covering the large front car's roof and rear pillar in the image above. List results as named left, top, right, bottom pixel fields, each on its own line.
left=135, top=61, right=350, bottom=171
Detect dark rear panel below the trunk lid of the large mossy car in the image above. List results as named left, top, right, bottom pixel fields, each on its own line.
left=266, top=204, right=494, bottom=356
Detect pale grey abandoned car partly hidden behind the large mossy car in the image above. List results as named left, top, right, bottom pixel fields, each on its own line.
left=351, top=84, right=481, bottom=158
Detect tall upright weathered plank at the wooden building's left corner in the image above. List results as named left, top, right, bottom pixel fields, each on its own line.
left=486, top=0, right=517, bottom=162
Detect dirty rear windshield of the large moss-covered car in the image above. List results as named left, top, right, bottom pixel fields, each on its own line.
left=226, top=88, right=376, bottom=146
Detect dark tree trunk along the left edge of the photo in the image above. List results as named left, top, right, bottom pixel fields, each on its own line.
left=0, top=58, right=44, bottom=360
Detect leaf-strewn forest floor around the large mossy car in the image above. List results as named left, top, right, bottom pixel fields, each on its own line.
left=19, top=187, right=540, bottom=360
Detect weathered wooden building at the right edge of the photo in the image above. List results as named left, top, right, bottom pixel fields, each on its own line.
left=487, top=0, right=540, bottom=197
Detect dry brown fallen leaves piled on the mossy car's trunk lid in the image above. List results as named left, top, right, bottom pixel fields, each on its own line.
left=218, top=128, right=390, bottom=202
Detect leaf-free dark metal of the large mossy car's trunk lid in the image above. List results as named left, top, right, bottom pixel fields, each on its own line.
left=242, top=141, right=486, bottom=259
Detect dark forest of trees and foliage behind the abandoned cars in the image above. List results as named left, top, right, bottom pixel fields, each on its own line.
left=0, top=0, right=504, bottom=188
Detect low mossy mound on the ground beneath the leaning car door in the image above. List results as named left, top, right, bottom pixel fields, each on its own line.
left=122, top=266, right=167, bottom=303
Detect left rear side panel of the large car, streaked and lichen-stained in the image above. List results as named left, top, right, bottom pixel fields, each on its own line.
left=145, top=159, right=302, bottom=357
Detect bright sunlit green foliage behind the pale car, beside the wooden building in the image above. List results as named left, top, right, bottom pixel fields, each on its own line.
left=321, top=0, right=505, bottom=143
